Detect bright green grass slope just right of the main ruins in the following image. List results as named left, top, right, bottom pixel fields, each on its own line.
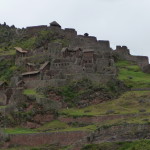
left=116, top=61, right=150, bottom=88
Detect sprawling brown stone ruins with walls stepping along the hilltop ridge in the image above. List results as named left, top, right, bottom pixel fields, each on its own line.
left=12, top=21, right=149, bottom=88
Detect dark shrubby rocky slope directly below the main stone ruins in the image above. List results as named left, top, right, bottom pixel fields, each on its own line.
left=38, top=78, right=126, bottom=108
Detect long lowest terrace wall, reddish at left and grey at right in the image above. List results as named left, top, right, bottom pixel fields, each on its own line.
left=8, top=124, right=150, bottom=147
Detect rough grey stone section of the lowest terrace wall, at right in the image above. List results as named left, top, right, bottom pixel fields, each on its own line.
left=90, top=124, right=150, bottom=143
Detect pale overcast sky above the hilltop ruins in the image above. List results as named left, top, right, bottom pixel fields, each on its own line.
left=0, top=0, right=150, bottom=58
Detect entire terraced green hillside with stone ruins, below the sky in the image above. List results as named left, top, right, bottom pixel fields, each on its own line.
left=0, top=22, right=150, bottom=150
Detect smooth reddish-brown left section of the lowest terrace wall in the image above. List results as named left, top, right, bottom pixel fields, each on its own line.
left=9, top=131, right=90, bottom=146
